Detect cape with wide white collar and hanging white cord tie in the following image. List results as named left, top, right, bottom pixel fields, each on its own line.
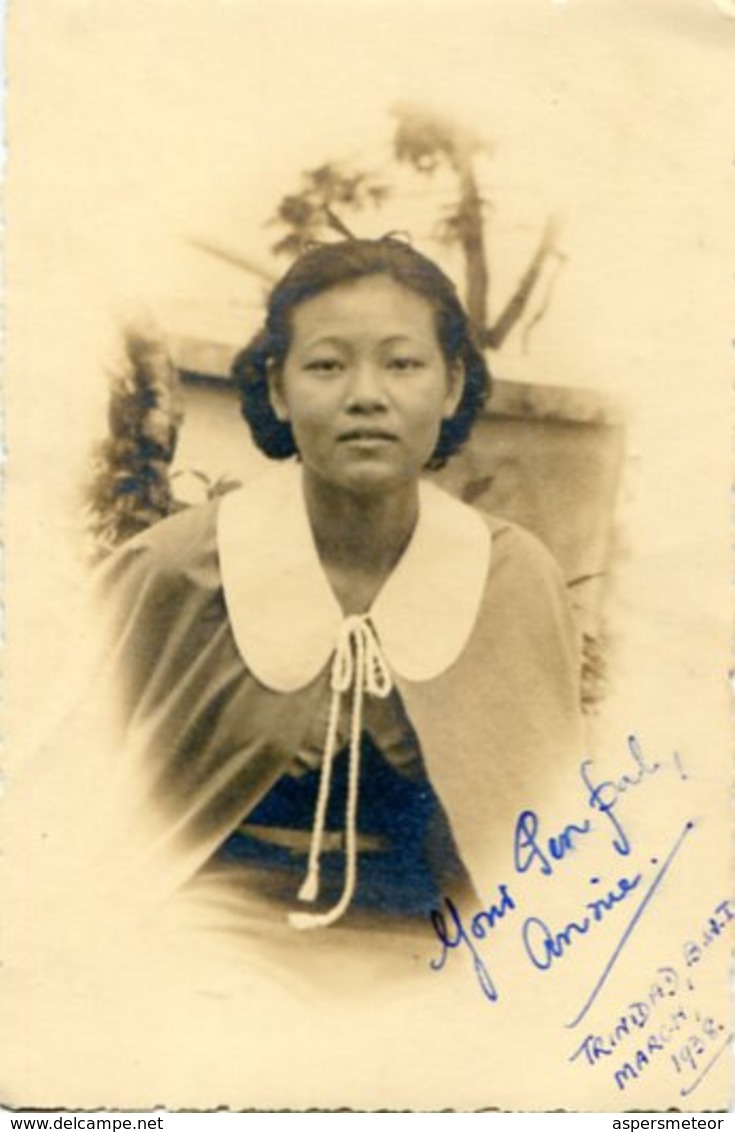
left=93, top=464, right=583, bottom=927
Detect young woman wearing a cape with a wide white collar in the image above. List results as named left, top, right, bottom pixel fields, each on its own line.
left=93, top=237, right=581, bottom=950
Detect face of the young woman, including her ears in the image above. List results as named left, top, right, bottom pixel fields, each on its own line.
left=271, top=275, right=463, bottom=492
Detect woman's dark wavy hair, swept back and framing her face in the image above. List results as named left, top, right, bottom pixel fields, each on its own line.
left=232, top=235, right=492, bottom=468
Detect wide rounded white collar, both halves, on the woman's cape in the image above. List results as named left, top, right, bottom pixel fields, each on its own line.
left=217, top=463, right=490, bottom=692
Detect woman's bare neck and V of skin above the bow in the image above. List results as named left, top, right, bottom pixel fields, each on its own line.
left=304, top=472, right=419, bottom=614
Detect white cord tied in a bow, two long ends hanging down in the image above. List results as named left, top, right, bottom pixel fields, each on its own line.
left=289, top=615, right=393, bottom=932
